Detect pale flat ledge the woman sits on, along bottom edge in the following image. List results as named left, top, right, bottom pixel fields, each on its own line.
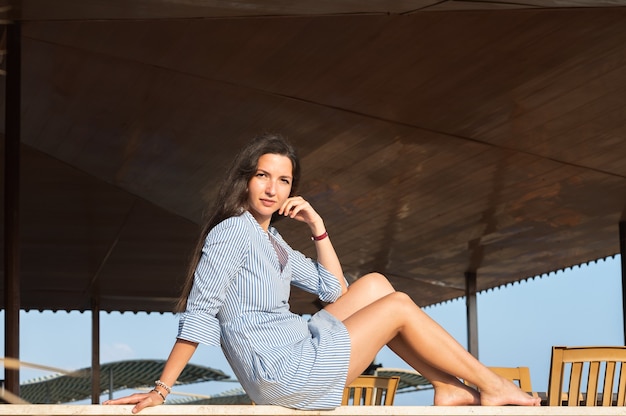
left=0, top=404, right=626, bottom=416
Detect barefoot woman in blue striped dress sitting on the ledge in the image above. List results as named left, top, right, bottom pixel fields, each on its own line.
left=104, top=135, right=539, bottom=413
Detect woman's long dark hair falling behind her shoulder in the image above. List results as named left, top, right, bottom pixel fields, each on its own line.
left=174, top=133, right=300, bottom=312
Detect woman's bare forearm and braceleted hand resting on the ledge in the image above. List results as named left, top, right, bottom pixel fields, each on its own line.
left=102, top=339, right=198, bottom=413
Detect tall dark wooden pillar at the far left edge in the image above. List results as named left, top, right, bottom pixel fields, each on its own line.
left=4, top=22, right=21, bottom=396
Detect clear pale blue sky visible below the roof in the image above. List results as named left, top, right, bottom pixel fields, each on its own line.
left=0, top=256, right=624, bottom=405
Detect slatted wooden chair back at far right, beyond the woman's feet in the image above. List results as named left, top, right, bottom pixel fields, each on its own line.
left=548, top=346, right=626, bottom=406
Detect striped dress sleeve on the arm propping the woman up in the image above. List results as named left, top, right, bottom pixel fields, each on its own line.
left=177, top=217, right=250, bottom=346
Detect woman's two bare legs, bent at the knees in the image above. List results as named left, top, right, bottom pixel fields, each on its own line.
left=326, top=274, right=539, bottom=405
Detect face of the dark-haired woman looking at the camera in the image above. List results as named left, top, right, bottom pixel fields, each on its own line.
left=248, top=153, right=293, bottom=230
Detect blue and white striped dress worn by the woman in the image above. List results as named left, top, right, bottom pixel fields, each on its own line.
left=178, top=211, right=350, bottom=410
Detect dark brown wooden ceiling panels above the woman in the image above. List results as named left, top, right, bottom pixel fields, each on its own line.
left=0, top=0, right=626, bottom=312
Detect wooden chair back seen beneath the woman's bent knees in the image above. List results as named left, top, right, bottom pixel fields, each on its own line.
left=341, top=375, right=400, bottom=406
